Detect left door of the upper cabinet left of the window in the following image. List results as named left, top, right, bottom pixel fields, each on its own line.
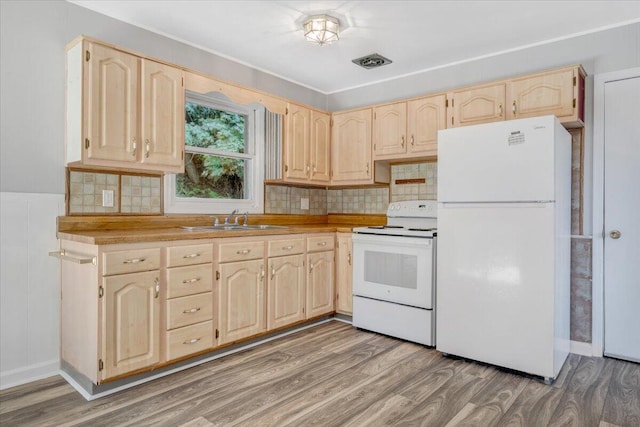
left=83, top=43, right=141, bottom=165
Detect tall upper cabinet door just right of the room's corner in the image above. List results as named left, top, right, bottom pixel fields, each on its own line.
left=331, top=108, right=373, bottom=184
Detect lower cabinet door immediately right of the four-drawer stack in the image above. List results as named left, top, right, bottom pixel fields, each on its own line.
left=218, top=260, right=266, bottom=344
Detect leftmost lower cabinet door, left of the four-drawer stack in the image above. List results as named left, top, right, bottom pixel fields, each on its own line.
left=102, top=271, right=160, bottom=380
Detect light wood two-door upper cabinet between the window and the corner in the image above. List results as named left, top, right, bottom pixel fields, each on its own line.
left=283, top=104, right=331, bottom=184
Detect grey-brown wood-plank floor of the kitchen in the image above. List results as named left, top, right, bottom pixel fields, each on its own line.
left=0, top=322, right=640, bottom=427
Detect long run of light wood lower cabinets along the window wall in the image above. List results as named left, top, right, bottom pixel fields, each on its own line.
left=58, top=233, right=342, bottom=390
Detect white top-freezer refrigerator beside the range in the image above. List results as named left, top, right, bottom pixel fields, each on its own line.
left=436, top=116, right=571, bottom=381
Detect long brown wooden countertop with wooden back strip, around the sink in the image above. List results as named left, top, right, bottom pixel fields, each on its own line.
left=57, top=214, right=386, bottom=245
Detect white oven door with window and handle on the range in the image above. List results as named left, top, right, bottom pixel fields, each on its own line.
left=353, top=233, right=434, bottom=309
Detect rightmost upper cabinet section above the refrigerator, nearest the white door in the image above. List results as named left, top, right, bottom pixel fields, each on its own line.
left=507, top=66, right=585, bottom=127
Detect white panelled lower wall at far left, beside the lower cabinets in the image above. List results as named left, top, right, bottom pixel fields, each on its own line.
left=0, top=192, right=64, bottom=389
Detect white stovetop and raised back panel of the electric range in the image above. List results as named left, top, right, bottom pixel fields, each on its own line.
left=353, top=200, right=438, bottom=238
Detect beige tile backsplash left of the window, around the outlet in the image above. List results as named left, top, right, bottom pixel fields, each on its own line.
left=68, top=170, right=162, bottom=215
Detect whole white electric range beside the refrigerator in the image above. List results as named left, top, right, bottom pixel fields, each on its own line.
left=353, top=200, right=437, bottom=346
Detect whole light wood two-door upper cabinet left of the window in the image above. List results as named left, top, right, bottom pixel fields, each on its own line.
left=66, top=40, right=184, bottom=172
